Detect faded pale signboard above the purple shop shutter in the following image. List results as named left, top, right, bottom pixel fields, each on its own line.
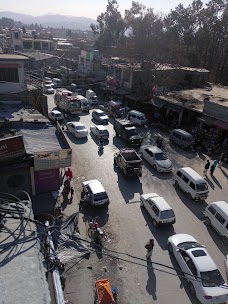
left=34, top=149, right=72, bottom=171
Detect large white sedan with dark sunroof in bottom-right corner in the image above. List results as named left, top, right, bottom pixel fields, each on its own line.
left=168, top=234, right=228, bottom=304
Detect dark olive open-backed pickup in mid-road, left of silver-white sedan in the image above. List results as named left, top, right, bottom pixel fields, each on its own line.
left=114, top=148, right=143, bottom=177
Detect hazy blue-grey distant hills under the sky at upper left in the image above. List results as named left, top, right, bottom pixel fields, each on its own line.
left=0, top=12, right=96, bottom=31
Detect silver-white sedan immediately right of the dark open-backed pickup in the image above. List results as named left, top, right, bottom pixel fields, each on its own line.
left=139, top=145, right=172, bottom=172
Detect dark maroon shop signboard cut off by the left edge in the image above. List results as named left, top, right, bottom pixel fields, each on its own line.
left=0, top=135, right=25, bottom=162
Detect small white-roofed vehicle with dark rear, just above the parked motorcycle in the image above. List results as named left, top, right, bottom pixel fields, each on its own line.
left=82, top=179, right=109, bottom=206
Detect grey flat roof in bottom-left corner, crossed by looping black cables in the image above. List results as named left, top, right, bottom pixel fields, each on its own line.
left=0, top=196, right=51, bottom=304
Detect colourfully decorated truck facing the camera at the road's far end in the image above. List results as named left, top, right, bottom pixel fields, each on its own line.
left=54, top=88, right=82, bottom=115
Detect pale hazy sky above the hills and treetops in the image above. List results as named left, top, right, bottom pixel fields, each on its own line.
left=0, top=0, right=209, bottom=19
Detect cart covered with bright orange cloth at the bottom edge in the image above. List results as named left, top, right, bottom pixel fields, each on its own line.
left=94, top=279, right=118, bottom=304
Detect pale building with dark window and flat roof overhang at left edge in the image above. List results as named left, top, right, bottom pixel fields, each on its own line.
left=0, top=54, right=28, bottom=93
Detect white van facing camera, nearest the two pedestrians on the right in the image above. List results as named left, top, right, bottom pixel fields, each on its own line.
left=173, top=167, right=209, bottom=200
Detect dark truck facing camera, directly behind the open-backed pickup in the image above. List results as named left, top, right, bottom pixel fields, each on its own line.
left=114, top=118, right=143, bottom=147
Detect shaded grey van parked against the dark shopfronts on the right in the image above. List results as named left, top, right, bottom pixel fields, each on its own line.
left=170, top=129, right=194, bottom=148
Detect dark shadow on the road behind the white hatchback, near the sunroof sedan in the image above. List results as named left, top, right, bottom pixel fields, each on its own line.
left=141, top=205, right=175, bottom=250
